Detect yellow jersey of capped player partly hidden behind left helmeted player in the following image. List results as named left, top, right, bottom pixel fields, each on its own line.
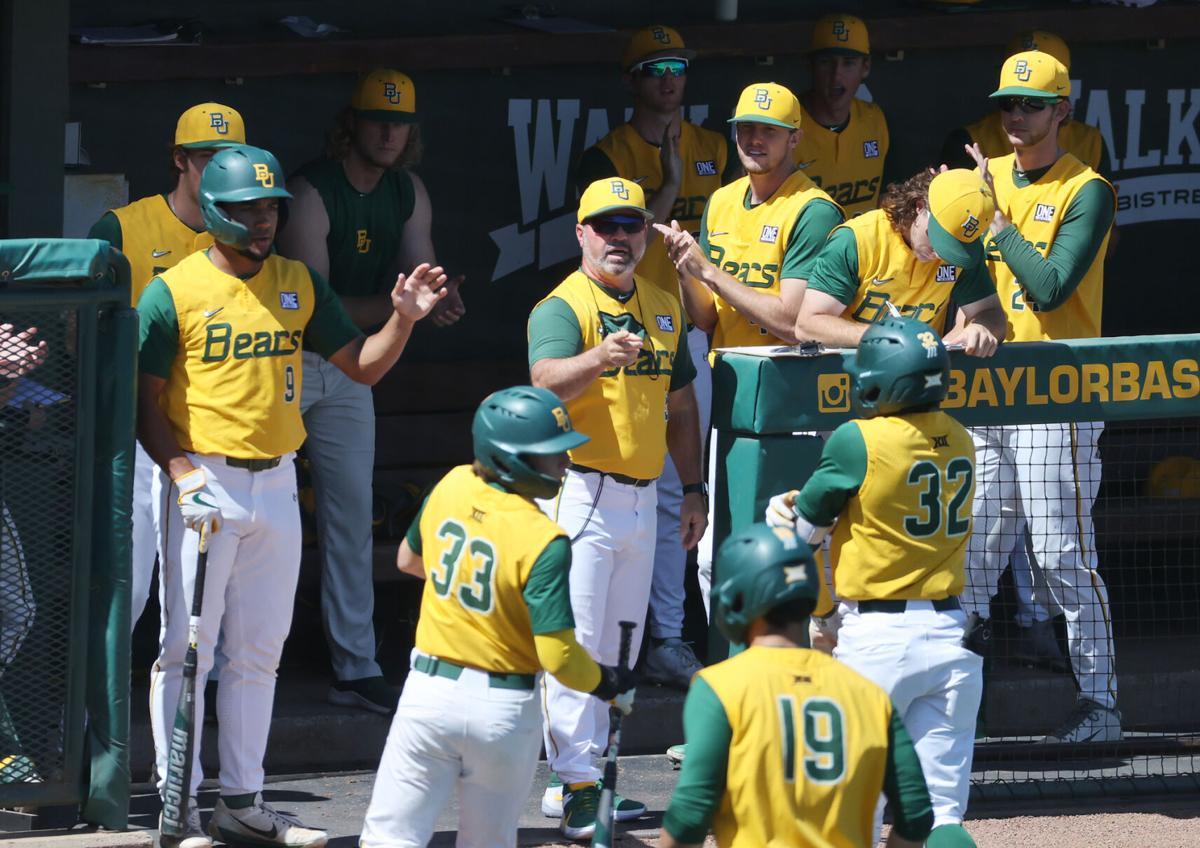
left=110, top=194, right=212, bottom=306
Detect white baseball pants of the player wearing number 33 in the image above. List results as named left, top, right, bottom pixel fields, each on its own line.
left=357, top=652, right=541, bottom=848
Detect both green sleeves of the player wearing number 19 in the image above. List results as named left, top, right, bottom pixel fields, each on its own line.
left=662, top=678, right=934, bottom=843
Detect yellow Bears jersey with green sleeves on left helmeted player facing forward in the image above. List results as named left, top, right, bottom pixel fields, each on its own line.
left=138, top=251, right=359, bottom=459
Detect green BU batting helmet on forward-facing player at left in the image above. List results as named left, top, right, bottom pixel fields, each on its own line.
left=200, top=144, right=292, bottom=251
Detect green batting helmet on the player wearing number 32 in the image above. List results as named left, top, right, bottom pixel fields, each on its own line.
left=850, top=318, right=950, bottom=419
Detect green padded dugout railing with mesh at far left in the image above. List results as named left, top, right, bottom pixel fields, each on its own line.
left=0, top=240, right=137, bottom=829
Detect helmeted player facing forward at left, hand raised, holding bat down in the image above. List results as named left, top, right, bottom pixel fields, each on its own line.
left=138, top=145, right=445, bottom=848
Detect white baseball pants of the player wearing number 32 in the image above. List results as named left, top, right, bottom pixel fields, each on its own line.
left=833, top=601, right=983, bottom=832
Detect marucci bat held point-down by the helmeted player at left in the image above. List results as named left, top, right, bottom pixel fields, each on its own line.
left=162, top=530, right=209, bottom=837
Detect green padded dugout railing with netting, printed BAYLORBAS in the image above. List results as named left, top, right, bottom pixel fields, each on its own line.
left=710, top=335, right=1200, bottom=795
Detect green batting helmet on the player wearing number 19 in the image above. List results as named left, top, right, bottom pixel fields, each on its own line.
left=713, top=523, right=820, bottom=643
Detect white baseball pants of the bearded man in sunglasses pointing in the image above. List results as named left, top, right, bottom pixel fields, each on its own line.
left=539, top=469, right=658, bottom=783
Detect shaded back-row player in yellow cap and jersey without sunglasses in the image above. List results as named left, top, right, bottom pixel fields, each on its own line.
left=792, top=13, right=892, bottom=217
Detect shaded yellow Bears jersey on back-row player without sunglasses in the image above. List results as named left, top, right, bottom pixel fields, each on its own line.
left=792, top=97, right=892, bottom=217
